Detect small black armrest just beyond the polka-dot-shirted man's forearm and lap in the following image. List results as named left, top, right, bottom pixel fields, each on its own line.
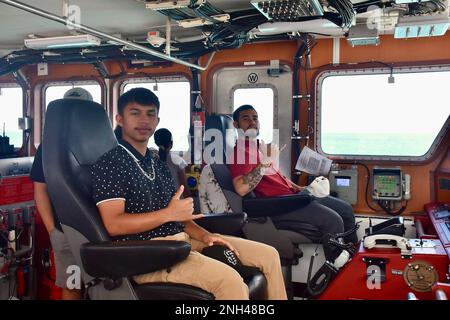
left=195, top=212, right=247, bottom=235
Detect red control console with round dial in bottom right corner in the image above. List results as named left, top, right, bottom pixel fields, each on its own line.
left=320, top=239, right=448, bottom=300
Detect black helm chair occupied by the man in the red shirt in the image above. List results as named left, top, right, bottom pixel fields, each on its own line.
left=205, top=114, right=320, bottom=296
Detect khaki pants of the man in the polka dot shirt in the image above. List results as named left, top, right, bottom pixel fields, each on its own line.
left=134, top=232, right=287, bottom=300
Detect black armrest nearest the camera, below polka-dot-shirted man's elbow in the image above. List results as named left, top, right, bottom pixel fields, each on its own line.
left=80, top=240, right=191, bottom=279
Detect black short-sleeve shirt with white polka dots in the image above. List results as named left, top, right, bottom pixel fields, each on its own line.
left=92, top=141, right=184, bottom=240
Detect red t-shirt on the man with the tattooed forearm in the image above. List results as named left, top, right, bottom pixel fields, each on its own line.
left=228, top=140, right=297, bottom=197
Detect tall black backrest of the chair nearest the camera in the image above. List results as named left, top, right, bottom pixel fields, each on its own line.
left=42, top=99, right=117, bottom=241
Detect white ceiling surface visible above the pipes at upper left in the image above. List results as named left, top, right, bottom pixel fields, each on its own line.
left=0, top=0, right=255, bottom=49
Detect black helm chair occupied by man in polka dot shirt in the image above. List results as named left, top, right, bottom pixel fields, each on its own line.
left=42, top=99, right=266, bottom=300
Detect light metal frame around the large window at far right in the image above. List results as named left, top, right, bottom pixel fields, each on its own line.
left=314, top=64, right=450, bottom=162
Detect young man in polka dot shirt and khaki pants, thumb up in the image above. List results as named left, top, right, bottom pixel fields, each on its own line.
left=92, top=88, right=286, bottom=300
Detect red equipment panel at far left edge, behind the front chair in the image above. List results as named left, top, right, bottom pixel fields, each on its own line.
left=0, top=157, right=61, bottom=299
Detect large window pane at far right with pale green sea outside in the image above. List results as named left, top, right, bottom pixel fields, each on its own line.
left=317, top=70, right=450, bottom=160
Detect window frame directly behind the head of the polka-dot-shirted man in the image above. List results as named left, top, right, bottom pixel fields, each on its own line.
left=119, top=74, right=193, bottom=154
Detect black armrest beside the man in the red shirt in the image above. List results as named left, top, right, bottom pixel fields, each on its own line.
left=242, top=194, right=314, bottom=218
